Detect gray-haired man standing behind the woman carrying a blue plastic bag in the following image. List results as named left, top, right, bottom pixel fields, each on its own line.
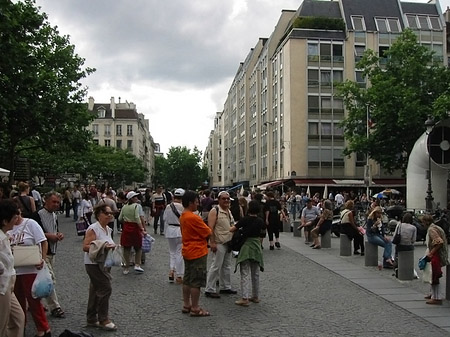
left=33, top=191, right=65, bottom=318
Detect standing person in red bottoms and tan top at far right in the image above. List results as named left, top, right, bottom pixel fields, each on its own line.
left=422, top=214, right=449, bottom=305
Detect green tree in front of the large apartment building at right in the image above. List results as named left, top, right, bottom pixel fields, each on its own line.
left=339, top=30, right=450, bottom=172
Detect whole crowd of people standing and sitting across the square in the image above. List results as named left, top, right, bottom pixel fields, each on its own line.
left=0, top=182, right=448, bottom=337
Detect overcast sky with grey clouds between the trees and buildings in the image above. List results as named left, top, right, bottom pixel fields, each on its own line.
left=36, top=0, right=450, bottom=153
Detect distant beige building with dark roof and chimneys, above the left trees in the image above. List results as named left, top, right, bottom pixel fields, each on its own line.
left=88, top=97, right=159, bottom=186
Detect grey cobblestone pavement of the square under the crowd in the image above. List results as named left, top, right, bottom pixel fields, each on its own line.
left=25, top=215, right=450, bottom=337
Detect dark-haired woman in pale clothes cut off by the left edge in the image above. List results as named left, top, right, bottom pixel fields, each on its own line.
left=0, top=199, right=25, bottom=337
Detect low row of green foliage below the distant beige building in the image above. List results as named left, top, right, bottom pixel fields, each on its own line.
left=25, top=144, right=148, bottom=186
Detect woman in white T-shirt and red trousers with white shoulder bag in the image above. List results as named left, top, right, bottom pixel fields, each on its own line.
left=7, top=201, right=51, bottom=337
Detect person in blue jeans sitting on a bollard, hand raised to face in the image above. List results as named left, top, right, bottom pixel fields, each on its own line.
left=366, top=206, right=394, bottom=269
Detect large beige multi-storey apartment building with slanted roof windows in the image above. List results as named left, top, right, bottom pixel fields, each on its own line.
left=206, top=0, right=447, bottom=187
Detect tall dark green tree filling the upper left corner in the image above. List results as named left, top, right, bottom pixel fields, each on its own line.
left=0, top=0, right=94, bottom=182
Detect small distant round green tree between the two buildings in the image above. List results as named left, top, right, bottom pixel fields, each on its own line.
left=154, top=146, right=207, bottom=189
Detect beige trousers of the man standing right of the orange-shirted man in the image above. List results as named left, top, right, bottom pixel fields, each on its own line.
left=205, top=243, right=231, bottom=293
